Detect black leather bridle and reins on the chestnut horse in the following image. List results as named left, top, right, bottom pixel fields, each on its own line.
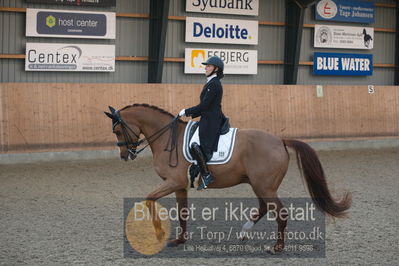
left=112, top=111, right=179, bottom=167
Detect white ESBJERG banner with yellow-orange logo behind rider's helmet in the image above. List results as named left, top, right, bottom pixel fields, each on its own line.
left=184, top=48, right=258, bottom=75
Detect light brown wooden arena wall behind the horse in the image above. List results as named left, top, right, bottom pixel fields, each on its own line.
left=0, top=83, right=399, bottom=153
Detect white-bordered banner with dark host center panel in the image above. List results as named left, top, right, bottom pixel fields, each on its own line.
left=26, top=8, right=115, bottom=39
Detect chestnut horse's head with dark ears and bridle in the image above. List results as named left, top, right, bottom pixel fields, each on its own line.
left=104, top=106, right=141, bottom=161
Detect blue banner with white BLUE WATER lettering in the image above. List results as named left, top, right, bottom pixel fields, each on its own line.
left=313, top=53, right=373, bottom=76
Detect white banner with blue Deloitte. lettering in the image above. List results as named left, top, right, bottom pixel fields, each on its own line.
left=186, top=17, right=258, bottom=45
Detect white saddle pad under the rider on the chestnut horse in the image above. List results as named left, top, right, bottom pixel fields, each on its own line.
left=183, top=120, right=237, bottom=164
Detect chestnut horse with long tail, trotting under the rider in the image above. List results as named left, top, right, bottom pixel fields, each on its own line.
left=105, top=104, right=351, bottom=252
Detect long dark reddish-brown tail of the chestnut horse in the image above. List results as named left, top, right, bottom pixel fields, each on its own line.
left=283, top=139, right=352, bottom=218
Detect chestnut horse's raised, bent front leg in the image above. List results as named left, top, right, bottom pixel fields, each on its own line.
left=146, top=180, right=181, bottom=241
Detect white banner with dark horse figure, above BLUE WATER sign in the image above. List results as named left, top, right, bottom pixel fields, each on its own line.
left=314, top=25, right=374, bottom=49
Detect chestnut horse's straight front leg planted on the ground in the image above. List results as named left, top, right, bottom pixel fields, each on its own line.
left=168, top=189, right=188, bottom=247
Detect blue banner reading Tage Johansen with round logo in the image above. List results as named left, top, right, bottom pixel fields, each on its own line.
left=315, top=0, right=374, bottom=24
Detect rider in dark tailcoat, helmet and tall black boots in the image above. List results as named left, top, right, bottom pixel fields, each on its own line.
left=179, top=56, right=226, bottom=190
